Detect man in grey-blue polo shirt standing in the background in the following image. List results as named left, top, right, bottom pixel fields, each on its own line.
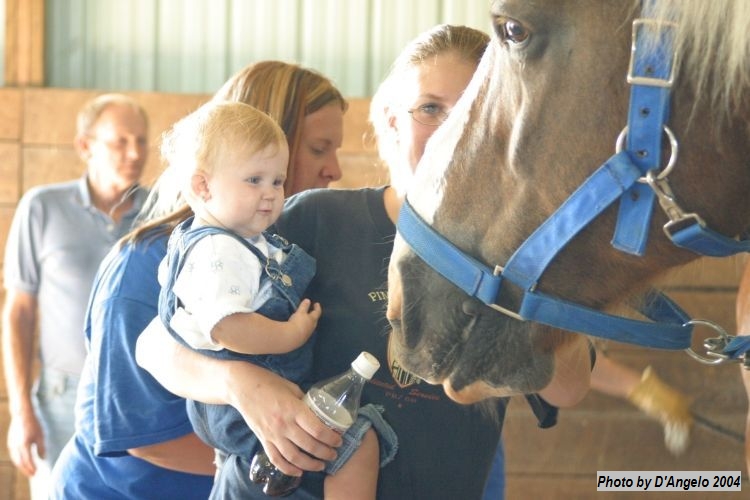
left=2, top=94, right=148, bottom=500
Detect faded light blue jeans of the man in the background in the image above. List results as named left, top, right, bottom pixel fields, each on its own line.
left=29, top=368, right=79, bottom=500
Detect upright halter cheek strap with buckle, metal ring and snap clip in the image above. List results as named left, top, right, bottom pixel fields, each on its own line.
left=612, top=15, right=750, bottom=257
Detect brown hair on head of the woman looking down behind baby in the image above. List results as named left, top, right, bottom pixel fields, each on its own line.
left=213, top=61, right=348, bottom=194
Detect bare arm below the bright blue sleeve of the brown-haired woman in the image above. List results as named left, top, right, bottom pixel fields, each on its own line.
left=128, top=433, right=216, bottom=476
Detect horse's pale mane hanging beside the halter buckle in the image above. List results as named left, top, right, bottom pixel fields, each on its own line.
left=649, top=0, right=750, bottom=112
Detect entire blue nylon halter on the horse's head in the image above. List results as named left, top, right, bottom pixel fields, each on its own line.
left=397, top=9, right=750, bottom=364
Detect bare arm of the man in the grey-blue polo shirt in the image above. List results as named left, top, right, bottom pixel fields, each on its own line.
left=2, top=290, right=45, bottom=476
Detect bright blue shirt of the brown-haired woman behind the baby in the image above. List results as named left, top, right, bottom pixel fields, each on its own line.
left=51, top=235, right=213, bottom=500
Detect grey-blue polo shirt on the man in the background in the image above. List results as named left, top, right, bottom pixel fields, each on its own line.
left=3, top=175, right=147, bottom=376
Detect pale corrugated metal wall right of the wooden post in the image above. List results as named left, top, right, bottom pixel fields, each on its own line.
left=44, top=0, right=496, bottom=97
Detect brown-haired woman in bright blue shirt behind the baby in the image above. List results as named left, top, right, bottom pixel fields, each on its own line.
left=51, top=61, right=347, bottom=499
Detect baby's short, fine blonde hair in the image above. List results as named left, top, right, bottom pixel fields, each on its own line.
left=161, top=101, right=287, bottom=207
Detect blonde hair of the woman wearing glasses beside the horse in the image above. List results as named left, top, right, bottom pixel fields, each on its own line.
left=370, top=24, right=490, bottom=193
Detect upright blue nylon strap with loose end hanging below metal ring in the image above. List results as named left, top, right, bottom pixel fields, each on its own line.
left=612, top=17, right=673, bottom=256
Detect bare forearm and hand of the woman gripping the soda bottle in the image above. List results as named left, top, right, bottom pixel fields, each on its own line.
left=136, top=318, right=341, bottom=475
